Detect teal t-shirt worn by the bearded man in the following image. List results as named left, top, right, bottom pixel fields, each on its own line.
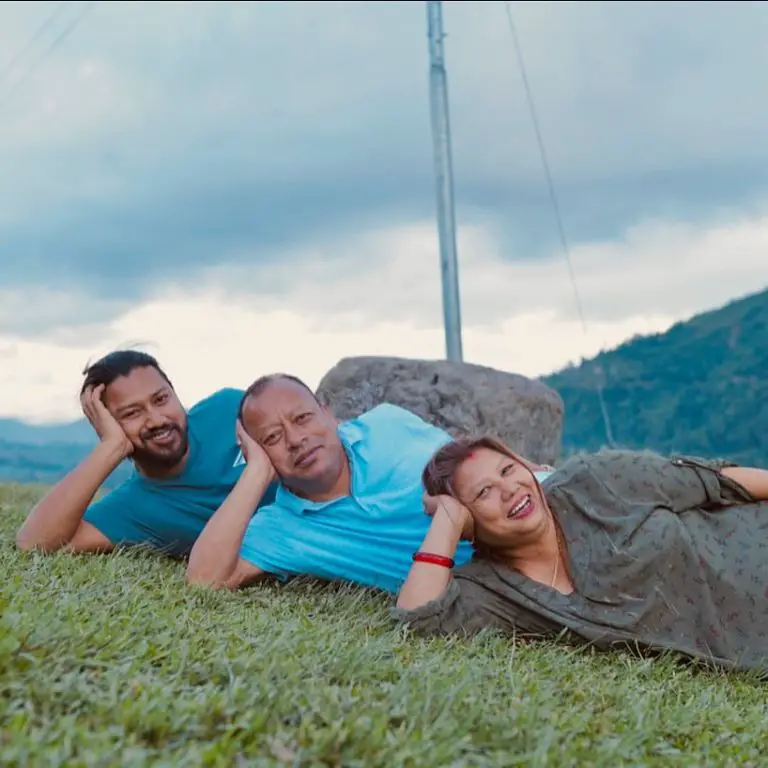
left=84, top=389, right=275, bottom=557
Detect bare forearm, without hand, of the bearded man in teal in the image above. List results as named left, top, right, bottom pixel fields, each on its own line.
left=16, top=443, right=125, bottom=552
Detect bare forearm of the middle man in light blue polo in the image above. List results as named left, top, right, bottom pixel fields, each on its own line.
left=187, top=466, right=271, bottom=584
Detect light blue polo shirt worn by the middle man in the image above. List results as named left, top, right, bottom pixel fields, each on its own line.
left=240, top=404, right=472, bottom=593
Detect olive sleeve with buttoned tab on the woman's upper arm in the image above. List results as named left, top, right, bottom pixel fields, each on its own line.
left=563, top=450, right=755, bottom=513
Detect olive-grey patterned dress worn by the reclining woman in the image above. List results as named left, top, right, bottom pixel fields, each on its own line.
left=394, top=451, right=768, bottom=670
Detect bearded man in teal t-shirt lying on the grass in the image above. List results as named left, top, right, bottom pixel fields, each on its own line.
left=17, top=350, right=274, bottom=557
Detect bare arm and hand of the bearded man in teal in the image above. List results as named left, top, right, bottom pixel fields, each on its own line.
left=16, top=387, right=131, bottom=553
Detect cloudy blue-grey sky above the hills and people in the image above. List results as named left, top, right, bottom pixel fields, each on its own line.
left=0, top=1, right=768, bottom=422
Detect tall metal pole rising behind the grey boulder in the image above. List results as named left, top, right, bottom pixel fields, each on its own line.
left=427, top=0, right=462, bottom=362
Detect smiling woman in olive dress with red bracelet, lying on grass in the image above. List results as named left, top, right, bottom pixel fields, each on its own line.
left=395, top=438, right=768, bottom=672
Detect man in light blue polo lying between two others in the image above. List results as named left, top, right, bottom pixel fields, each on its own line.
left=187, top=374, right=552, bottom=592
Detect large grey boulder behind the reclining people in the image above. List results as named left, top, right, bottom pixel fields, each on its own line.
left=317, top=357, right=563, bottom=464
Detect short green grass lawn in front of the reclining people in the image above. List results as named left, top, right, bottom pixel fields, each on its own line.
left=0, top=486, right=768, bottom=768
